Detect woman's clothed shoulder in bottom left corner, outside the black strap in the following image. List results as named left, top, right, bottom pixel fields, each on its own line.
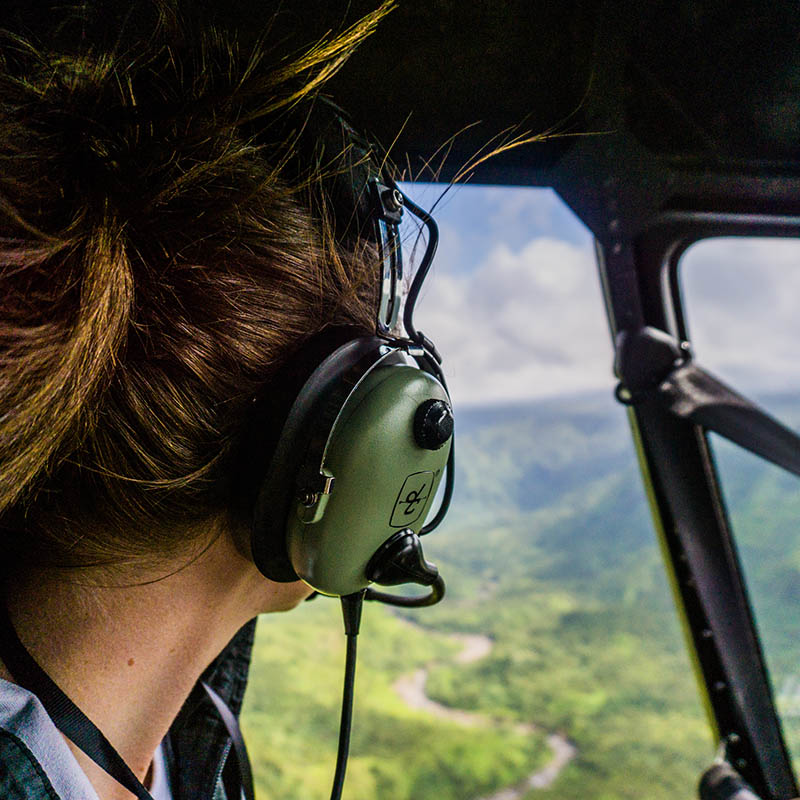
left=0, top=679, right=98, bottom=800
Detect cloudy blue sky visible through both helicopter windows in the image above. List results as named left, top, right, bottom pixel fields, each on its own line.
left=403, top=179, right=800, bottom=406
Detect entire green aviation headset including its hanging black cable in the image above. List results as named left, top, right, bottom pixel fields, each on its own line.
left=241, top=108, right=455, bottom=800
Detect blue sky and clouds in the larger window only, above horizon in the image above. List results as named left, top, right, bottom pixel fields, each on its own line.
left=404, top=184, right=613, bottom=405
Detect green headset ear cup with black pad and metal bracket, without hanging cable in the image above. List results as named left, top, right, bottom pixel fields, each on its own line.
left=251, top=117, right=454, bottom=605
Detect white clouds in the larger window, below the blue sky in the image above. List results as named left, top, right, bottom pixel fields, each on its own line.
left=417, top=228, right=613, bottom=405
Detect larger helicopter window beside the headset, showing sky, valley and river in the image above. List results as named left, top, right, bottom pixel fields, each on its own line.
left=243, top=183, right=713, bottom=800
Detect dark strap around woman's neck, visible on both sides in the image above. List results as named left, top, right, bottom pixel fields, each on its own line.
left=0, top=603, right=254, bottom=800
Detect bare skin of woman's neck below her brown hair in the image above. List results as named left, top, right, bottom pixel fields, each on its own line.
left=0, top=536, right=307, bottom=800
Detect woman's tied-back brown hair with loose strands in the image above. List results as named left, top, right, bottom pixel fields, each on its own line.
left=0, top=1, right=390, bottom=566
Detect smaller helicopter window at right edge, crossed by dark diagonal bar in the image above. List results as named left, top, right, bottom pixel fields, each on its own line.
left=680, top=237, right=800, bottom=771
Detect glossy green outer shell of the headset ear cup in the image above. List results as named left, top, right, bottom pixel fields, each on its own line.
left=288, top=357, right=452, bottom=595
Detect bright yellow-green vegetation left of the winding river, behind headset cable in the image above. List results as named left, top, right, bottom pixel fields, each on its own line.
left=243, top=600, right=547, bottom=800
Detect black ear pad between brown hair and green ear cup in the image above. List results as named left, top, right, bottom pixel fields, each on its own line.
left=251, top=337, right=391, bottom=582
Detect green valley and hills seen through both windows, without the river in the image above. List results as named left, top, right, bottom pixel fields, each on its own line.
left=244, top=390, right=800, bottom=800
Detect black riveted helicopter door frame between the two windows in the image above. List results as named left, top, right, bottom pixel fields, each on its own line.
left=596, top=211, right=800, bottom=800
